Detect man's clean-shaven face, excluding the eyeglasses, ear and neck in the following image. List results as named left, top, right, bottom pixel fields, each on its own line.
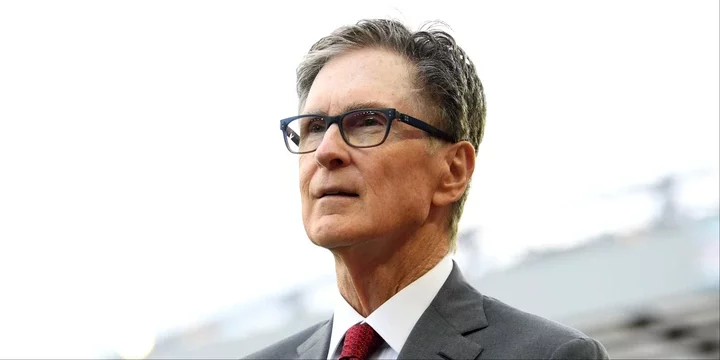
left=300, top=49, right=442, bottom=249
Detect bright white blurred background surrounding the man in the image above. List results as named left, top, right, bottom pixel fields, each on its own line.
left=0, top=0, right=720, bottom=359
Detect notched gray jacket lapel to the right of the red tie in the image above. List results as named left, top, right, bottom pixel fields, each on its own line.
left=398, top=262, right=488, bottom=360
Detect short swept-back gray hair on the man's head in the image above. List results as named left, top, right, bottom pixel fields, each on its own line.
left=297, top=19, right=486, bottom=251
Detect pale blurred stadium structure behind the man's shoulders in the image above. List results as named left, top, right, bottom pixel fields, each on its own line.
left=131, top=172, right=720, bottom=359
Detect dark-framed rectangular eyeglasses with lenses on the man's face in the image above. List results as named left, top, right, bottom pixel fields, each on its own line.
left=280, top=109, right=457, bottom=154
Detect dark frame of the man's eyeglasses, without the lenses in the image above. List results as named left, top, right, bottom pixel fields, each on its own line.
left=280, top=108, right=458, bottom=154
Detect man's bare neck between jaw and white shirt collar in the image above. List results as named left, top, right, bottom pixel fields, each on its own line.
left=333, top=224, right=449, bottom=317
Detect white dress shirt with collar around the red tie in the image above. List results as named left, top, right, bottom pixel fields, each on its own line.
left=328, top=255, right=453, bottom=360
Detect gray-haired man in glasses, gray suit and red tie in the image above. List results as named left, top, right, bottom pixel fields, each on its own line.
left=248, top=20, right=607, bottom=359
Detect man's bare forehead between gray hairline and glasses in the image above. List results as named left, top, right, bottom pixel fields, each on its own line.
left=303, top=48, right=414, bottom=115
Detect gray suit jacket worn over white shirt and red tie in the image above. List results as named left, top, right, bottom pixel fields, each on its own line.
left=246, top=264, right=608, bottom=360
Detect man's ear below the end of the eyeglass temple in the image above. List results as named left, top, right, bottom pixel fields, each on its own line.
left=433, top=141, right=475, bottom=206
